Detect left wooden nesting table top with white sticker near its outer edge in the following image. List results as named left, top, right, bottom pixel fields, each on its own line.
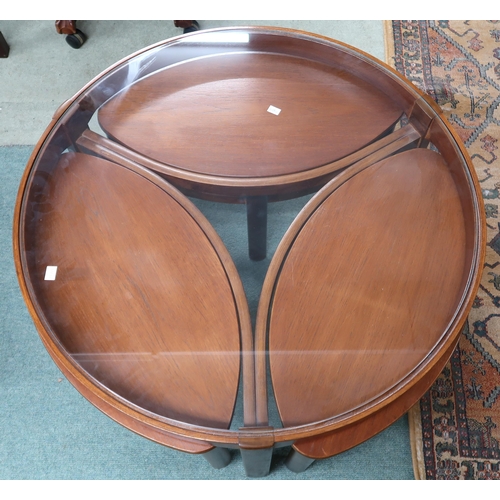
left=20, top=153, right=251, bottom=428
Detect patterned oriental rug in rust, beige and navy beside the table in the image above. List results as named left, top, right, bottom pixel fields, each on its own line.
left=385, top=21, right=500, bottom=479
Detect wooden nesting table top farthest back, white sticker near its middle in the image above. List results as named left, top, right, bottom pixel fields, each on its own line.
left=99, top=52, right=402, bottom=178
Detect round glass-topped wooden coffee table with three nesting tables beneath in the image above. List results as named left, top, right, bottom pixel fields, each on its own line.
left=14, top=28, right=485, bottom=476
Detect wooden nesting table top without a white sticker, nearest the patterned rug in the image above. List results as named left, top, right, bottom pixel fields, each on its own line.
left=257, top=150, right=470, bottom=426
